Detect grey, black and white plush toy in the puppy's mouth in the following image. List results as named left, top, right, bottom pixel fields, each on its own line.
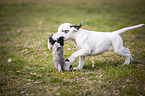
left=48, top=34, right=73, bottom=72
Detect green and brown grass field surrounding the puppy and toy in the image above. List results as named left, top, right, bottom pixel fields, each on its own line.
left=0, top=0, right=145, bottom=96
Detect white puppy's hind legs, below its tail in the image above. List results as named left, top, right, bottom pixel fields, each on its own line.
left=114, top=46, right=133, bottom=65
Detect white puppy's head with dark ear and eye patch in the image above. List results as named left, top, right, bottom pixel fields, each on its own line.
left=56, top=21, right=83, bottom=40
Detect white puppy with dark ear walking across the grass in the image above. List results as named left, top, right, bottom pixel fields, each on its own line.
left=48, top=22, right=144, bottom=70
